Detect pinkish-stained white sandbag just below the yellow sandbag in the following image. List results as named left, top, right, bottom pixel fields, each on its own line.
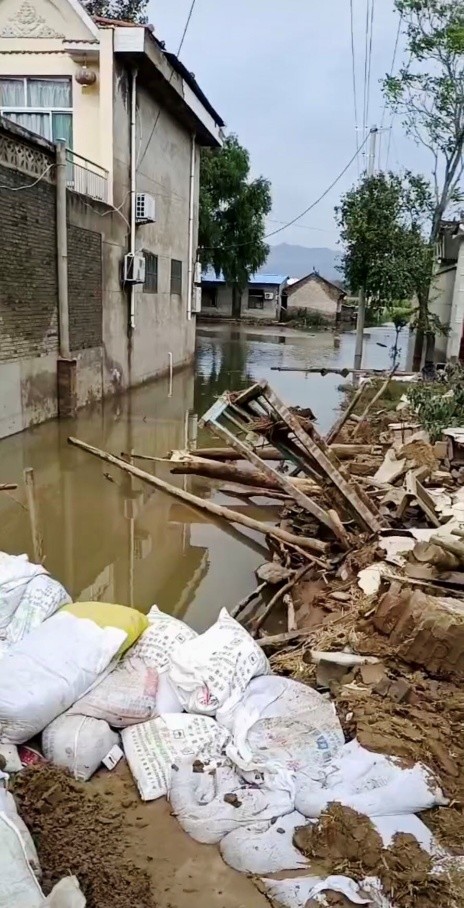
left=70, top=656, right=158, bottom=728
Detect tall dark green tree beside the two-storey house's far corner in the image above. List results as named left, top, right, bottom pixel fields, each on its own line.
left=199, top=135, right=272, bottom=318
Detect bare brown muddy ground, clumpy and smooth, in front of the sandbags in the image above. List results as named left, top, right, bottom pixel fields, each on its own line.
left=14, top=762, right=268, bottom=908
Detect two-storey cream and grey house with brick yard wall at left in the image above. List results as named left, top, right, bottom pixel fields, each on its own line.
left=0, top=0, right=224, bottom=437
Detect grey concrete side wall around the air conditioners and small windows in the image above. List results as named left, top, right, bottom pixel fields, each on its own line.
left=112, top=66, right=196, bottom=383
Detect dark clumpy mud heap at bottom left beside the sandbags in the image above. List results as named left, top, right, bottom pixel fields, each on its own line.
left=12, top=765, right=157, bottom=908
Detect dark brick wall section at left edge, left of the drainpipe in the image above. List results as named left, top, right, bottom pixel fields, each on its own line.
left=0, top=164, right=58, bottom=362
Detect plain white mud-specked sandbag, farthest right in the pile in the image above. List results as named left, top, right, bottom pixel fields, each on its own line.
left=295, top=741, right=448, bottom=817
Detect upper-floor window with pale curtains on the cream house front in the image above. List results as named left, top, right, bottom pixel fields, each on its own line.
left=0, top=77, right=72, bottom=148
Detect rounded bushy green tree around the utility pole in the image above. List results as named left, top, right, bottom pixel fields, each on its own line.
left=335, top=173, right=432, bottom=318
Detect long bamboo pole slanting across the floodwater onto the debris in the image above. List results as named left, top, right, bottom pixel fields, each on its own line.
left=68, top=437, right=329, bottom=557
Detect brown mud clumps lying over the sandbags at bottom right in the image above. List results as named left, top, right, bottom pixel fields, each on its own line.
left=293, top=804, right=464, bottom=908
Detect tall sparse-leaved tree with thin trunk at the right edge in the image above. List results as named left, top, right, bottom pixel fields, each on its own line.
left=384, top=0, right=464, bottom=368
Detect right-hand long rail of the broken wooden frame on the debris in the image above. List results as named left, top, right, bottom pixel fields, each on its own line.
left=264, top=385, right=382, bottom=532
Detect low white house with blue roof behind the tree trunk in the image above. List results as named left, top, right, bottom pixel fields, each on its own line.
left=201, top=269, right=287, bottom=321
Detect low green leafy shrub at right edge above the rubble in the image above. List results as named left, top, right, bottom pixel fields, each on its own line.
left=407, top=364, right=464, bottom=441
